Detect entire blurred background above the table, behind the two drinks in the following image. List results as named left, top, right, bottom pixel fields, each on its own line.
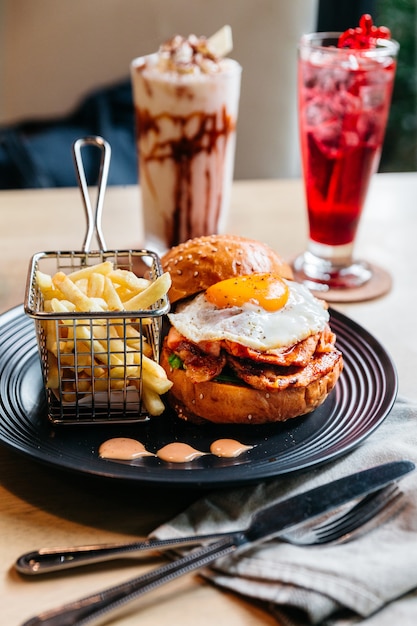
left=0, top=0, right=417, bottom=189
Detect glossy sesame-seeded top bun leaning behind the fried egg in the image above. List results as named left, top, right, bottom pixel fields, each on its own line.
left=161, top=235, right=293, bottom=304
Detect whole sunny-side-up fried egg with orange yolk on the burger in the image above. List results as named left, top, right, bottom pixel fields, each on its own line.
left=168, top=274, right=329, bottom=351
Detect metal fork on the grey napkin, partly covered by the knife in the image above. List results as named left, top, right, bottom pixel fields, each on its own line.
left=15, top=484, right=402, bottom=575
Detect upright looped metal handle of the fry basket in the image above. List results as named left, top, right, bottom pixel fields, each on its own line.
left=73, top=136, right=111, bottom=252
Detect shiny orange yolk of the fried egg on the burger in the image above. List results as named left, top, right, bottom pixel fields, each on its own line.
left=205, top=274, right=289, bottom=311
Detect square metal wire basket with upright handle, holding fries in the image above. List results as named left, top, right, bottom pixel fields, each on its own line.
left=25, top=137, right=169, bottom=424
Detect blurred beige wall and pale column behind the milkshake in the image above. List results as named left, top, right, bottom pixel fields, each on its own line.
left=0, top=0, right=317, bottom=178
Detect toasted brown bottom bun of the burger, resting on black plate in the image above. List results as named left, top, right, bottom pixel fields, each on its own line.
left=161, top=342, right=343, bottom=424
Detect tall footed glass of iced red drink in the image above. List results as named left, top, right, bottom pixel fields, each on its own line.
left=294, top=33, right=399, bottom=291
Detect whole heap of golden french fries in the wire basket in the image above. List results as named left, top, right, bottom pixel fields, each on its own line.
left=36, top=261, right=172, bottom=415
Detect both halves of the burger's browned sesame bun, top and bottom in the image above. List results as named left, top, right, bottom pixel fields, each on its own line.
left=160, top=235, right=343, bottom=424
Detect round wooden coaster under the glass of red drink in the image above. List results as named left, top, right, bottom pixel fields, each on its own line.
left=312, top=263, right=392, bottom=302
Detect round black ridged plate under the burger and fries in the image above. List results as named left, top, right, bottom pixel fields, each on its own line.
left=0, top=307, right=397, bottom=488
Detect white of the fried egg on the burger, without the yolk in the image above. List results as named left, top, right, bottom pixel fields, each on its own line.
left=168, top=281, right=329, bottom=351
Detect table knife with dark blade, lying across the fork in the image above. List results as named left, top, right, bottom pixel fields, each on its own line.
left=22, top=461, right=415, bottom=626
